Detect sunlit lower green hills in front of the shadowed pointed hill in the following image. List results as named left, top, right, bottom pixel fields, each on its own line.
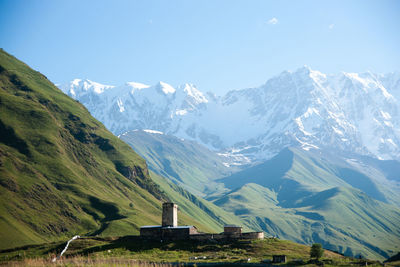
left=215, top=184, right=400, bottom=260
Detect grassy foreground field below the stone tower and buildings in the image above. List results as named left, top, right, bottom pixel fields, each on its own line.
left=0, top=236, right=388, bottom=266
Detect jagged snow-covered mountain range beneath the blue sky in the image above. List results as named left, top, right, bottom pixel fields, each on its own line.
left=60, top=67, right=400, bottom=161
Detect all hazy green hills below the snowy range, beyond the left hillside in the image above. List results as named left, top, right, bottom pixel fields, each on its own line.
left=120, top=130, right=400, bottom=259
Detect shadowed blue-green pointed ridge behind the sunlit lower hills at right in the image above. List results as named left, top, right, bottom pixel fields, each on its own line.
left=216, top=148, right=400, bottom=206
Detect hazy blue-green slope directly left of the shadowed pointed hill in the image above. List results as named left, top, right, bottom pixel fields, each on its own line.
left=120, top=131, right=238, bottom=196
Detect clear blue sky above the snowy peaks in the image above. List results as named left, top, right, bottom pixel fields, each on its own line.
left=0, top=0, right=400, bottom=94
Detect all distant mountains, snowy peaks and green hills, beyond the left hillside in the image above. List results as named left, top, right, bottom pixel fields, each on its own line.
left=59, top=67, right=400, bottom=259
